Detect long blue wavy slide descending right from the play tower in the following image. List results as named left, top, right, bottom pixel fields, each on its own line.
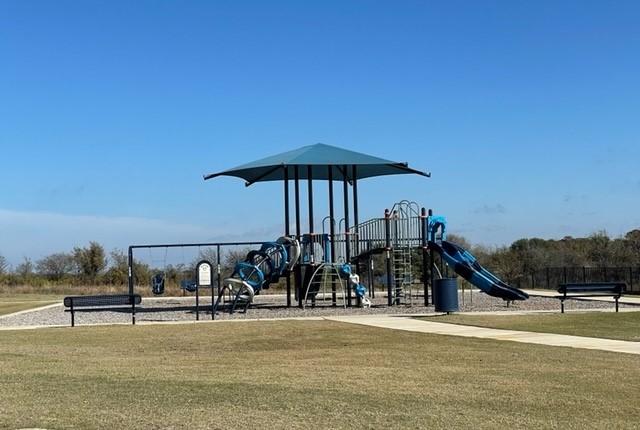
left=429, top=240, right=529, bottom=301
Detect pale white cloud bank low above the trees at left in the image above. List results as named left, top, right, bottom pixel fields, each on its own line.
left=0, top=209, right=277, bottom=265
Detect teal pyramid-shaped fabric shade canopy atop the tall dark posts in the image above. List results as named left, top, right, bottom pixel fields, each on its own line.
left=204, top=143, right=431, bottom=186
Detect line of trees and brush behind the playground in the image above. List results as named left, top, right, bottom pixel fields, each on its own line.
left=0, top=229, right=640, bottom=286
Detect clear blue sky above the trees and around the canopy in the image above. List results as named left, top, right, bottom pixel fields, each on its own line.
left=0, top=0, right=640, bottom=264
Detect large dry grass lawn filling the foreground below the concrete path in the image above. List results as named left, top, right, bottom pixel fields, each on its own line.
left=0, top=321, right=640, bottom=429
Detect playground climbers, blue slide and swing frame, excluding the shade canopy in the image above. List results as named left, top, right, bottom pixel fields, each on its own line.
left=129, top=200, right=528, bottom=318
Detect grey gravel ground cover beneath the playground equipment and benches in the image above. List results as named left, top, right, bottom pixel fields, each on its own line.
left=0, top=291, right=626, bottom=327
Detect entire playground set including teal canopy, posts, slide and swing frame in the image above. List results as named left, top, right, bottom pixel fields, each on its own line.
left=129, top=144, right=527, bottom=318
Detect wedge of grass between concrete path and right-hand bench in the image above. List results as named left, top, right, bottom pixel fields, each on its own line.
left=422, top=312, right=640, bottom=342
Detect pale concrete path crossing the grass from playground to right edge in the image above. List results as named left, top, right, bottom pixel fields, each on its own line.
left=326, top=315, right=640, bottom=355
